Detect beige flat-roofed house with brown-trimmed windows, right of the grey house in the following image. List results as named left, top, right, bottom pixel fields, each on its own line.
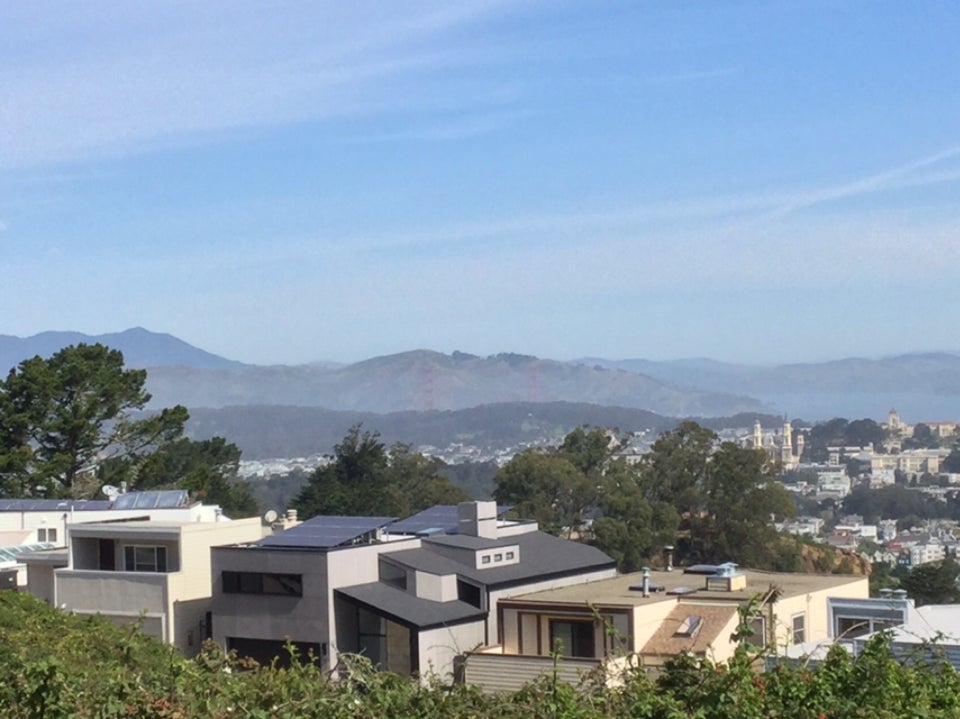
left=464, top=564, right=869, bottom=691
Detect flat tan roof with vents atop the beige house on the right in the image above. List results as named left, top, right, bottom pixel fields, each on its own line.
left=502, top=569, right=867, bottom=606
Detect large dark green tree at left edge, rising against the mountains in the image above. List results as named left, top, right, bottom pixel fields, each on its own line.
left=0, top=344, right=257, bottom=516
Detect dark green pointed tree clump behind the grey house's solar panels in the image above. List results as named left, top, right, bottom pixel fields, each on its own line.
left=292, top=425, right=470, bottom=519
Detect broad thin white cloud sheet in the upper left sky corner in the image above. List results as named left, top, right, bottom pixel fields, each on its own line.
left=0, top=2, right=524, bottom=168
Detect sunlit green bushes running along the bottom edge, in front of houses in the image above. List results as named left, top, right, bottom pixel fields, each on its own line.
left=0, top=593, right=960, bottom=719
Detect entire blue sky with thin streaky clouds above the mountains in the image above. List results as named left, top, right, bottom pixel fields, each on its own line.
left=0, top=0, right=960, bottom=363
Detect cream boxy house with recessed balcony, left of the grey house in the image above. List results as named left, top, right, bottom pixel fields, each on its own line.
left=23, top=517, right=263, bottom=657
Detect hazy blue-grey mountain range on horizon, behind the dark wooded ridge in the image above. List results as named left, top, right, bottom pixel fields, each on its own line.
left=0, top=328, right=960, bottom=421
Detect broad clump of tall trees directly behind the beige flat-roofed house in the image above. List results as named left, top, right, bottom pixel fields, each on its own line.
left=494, top=422, right=796, bottom=571
